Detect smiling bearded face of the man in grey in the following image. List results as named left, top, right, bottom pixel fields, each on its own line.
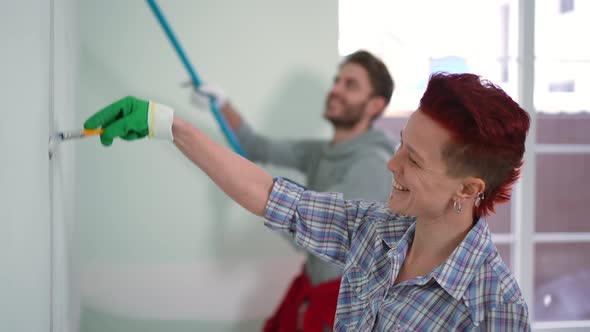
left=324, top=63, right=373, bottom=128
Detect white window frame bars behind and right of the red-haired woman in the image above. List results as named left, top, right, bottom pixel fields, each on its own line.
left=342, top=0, right=590, bottom=332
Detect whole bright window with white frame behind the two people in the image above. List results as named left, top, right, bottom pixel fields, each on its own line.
left=338, top=0, right=590, bottom=331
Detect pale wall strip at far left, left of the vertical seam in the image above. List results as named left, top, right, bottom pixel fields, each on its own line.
left=0, top=0, right=51, bottom=331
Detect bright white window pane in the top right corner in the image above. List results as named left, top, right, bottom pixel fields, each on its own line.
left=535, top=0, right=590, bottom=113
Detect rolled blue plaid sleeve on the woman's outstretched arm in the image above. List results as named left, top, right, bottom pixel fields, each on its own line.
left=264, top=178, right=382, bottom=268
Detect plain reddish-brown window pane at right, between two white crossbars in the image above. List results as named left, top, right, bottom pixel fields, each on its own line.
left=536, top=154, right=590, bottom=232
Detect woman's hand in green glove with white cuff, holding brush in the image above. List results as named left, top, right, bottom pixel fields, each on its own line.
left=84, top=96, right=174, bottom=146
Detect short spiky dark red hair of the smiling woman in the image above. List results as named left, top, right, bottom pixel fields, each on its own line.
left=420, top=73, right=530, bottom=217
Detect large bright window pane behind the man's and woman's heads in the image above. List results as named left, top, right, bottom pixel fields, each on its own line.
left=338, top=0, right=518, bottom=113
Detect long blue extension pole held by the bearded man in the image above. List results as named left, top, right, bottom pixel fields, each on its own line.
left=147, top=0, right=246, bottom=157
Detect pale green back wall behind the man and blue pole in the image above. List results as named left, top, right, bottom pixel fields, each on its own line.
left=72, top=0, right=339, bottom=331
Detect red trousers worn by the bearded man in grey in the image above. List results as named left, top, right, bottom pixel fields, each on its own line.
left=263, top=267, right=340, bottom=332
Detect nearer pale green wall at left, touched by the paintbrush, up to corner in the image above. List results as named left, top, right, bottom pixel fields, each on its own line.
left=0, top=0, right=79, bottom=332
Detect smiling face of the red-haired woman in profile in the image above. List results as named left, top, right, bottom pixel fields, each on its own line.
left=387, top=110, right=462, bottom=219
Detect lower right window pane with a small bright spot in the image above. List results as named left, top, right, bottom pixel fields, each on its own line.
left=534, top=243, right=590, bottom=321
